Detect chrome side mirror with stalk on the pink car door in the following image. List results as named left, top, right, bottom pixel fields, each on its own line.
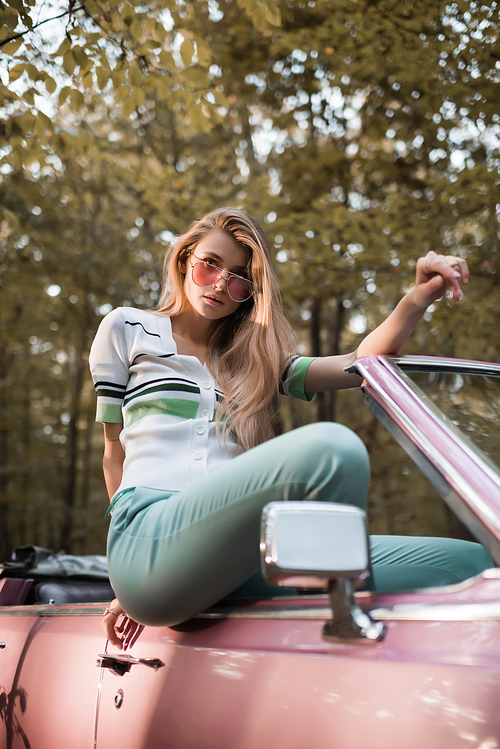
left=260, top=501, right=385, bottom=642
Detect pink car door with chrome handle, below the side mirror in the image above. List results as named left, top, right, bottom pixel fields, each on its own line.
left=97, top=576, right=500, bottom=749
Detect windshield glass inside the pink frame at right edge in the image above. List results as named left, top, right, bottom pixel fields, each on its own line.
left=403, top=367, right=500, bottom=480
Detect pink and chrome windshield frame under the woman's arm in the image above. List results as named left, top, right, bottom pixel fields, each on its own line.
left=348, top=355, right=500, bottom=564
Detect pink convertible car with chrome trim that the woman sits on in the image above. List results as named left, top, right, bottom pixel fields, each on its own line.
left=0, top=356, right=500, bottom=749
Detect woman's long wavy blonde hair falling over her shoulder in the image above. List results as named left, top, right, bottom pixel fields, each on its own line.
left=157, top=208, right=295, bottom=450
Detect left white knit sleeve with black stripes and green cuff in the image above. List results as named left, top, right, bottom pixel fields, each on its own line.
left=89, top=308, right=129, bottom=424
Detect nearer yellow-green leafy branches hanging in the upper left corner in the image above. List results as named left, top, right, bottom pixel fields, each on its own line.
left=0, top=0, right=279, bottom=169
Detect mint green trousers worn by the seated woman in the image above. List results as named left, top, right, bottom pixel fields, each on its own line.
left=107, top=423, right=494, bottom=626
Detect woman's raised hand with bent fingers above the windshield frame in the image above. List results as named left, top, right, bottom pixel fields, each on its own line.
left=413, top=250, right=469, bottom=309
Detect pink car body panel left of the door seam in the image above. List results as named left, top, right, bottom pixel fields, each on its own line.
left=0, top=604, right=106, bottom=749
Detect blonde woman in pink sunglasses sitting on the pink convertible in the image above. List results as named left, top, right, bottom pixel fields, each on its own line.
left=90, top=208, right=491, bottom=647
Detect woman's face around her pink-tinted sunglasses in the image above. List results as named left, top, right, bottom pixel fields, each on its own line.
left=184, top=231, right=248, bottom=320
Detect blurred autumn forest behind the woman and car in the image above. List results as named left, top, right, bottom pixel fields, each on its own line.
left=0, top=0, right=500, bottom=558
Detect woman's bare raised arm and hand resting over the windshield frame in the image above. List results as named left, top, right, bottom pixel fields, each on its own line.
left=305, top=251, right=469, bottom=393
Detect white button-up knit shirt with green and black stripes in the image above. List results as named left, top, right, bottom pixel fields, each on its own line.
left=89, top=307, right=312, bottom=491
